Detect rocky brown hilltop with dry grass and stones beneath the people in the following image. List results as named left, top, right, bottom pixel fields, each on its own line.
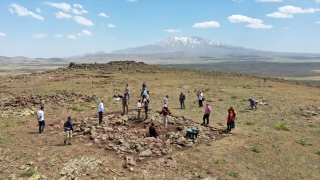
left=0, top=61, right=320, bottom=179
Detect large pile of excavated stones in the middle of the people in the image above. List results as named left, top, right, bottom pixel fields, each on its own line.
left=69, top=112, right=219, bottom=161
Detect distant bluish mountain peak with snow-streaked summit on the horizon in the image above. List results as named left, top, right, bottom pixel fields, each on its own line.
left=112, top=36, right=255, bottom=54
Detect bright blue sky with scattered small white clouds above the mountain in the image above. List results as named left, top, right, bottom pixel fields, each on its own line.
left=0, top=0, right=320, bottom=58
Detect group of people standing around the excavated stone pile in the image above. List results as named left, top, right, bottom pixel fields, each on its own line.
left=37, top=82, right=257, bottom=145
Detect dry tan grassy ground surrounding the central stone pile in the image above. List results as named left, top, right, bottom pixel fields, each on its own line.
left=0, top=62, right=320, bottom=180
